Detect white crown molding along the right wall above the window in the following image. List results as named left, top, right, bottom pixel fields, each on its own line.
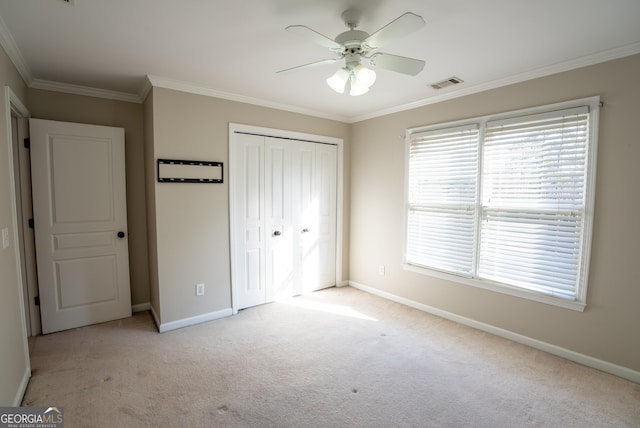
left=348, top=42, right=640, bottom=123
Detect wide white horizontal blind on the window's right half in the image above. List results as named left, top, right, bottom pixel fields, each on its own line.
left=478, top=107, right=589, bottom=299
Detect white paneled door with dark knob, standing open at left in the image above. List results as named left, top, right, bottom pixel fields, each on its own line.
left=30, top=119, right=131, bottom=333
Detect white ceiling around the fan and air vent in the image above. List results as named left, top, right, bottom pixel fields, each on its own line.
left=0, top=0, right=640, bottom=122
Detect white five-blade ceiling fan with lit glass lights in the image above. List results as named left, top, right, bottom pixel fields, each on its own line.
left=278, top=9, right=425, bottom=96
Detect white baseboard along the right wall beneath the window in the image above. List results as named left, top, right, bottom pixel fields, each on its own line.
left=349, top=281, right=640, bottom=383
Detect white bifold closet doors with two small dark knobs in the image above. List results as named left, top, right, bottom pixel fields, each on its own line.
left=231, top=134, right=337, bottom=309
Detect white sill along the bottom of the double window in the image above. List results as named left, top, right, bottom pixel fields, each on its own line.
left=402, top=263, right=587, bottom=312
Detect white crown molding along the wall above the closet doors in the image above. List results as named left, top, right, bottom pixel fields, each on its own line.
left=147, top=75, right=349, bottom=123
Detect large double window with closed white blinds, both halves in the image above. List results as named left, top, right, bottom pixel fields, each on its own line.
left=404, top=97, right=599, bottom=310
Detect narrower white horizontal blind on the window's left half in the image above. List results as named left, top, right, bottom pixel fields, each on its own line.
left=406, top=125, right=478, bottom=276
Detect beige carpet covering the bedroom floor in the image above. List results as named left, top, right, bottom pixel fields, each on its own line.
left=23, top=287, right=640, bottom=428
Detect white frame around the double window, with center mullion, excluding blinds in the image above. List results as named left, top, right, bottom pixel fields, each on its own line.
left=402, top=96, right=601, bottom=311
